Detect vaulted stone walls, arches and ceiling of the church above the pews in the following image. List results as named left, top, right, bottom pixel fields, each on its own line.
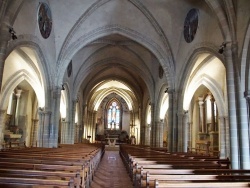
left=0, top=0, right=250, bottom=169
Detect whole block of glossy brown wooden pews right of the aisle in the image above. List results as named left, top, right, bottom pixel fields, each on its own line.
left=120, top=144, right=250, bottom=187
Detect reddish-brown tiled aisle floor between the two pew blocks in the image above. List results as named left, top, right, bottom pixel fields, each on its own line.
left=90, top=151, right=133, bottom=188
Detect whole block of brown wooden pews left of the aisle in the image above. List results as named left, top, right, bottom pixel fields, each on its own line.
left=0, top=145, right=105, bottom=187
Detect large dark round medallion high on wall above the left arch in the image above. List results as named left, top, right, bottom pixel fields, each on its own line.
left=37, top=3, right=52, bottom=39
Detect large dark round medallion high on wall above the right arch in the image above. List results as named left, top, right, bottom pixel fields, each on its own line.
left=183, top=8, right=199, bottom=43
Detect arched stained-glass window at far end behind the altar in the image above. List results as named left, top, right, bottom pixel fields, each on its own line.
left=107, top=101, right=120, bottom=129
